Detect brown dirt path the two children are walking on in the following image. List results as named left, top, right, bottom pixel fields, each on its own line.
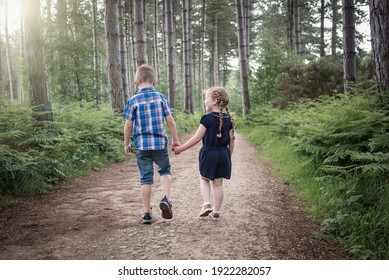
left=0, top=134, right=347, bottom=260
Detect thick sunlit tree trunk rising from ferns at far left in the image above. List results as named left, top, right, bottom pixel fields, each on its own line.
left=23, top=0, right=53, bottom=121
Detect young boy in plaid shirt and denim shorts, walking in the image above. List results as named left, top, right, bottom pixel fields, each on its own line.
left=123, top=64, right=180, bottom=224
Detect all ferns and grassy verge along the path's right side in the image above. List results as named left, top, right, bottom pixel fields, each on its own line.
left=239, top=89, right=389, bottom=259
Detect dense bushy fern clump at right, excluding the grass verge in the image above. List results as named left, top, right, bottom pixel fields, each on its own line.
left=282, top=92, right=389, bottom=178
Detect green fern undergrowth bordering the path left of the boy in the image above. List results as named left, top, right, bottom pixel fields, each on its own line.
left=0, top=100, right=124, bottom=195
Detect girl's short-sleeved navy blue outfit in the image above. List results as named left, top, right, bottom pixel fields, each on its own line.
left=199, top=112, right=232, bottom=181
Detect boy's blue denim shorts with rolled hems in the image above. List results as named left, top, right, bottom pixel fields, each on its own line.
left=136, top=147, right=171, bottom=185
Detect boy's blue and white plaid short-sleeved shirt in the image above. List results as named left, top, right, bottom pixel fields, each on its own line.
left=123, top=88, right=171, bottom=151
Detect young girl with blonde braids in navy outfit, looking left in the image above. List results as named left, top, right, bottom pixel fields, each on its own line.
left=173, top=87, right=235, bottom=221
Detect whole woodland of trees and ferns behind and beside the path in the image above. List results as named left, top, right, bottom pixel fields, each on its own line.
left=0, top=0, right=389, bottom=259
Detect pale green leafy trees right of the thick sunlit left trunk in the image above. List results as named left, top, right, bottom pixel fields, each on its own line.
left=44, top=1, right=108, bottom=103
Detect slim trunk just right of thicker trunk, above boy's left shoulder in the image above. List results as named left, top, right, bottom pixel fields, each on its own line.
left=118, top=0, right=129, bottom=100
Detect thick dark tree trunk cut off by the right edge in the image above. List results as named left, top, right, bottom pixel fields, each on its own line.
left=370, top=0, right=389, bottom=94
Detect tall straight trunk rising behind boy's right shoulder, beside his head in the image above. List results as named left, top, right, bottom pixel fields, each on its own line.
left=165, top=0, right=175, bottom=108
